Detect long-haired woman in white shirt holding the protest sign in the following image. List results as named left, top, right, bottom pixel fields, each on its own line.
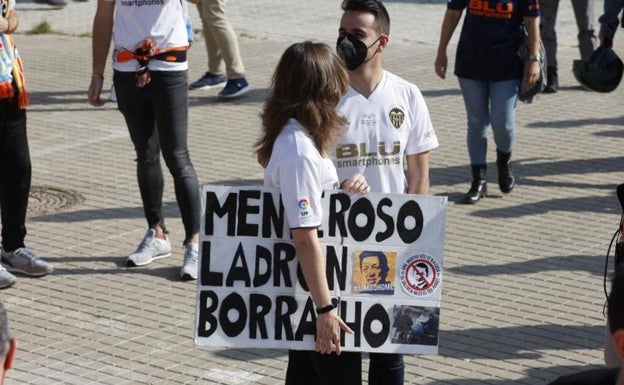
left=256, top=42, right=369, bottom=385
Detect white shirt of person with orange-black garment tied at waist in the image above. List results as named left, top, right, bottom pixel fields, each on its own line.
left=106, top=0, right=188, bottom=72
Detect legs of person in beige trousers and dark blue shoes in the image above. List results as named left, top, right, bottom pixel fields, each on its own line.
left=189, top=0, right=251, bottom=99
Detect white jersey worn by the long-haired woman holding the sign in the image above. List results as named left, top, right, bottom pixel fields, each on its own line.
left=264, top=119, right=338, bottom=229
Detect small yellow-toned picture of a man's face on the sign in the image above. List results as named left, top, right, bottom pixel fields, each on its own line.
left=352, top=250, right=396, bottom=295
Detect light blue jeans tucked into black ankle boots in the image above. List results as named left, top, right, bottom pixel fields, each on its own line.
left=459, top=78, right=521, bottom=165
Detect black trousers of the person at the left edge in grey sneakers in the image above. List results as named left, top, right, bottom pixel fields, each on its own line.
left=0, top=99, right=32, bottom=251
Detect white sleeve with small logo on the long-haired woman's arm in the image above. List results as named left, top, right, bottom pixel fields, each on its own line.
left=278, top=157, right=323, bottom=229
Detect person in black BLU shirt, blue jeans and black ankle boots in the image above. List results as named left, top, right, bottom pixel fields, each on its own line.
left=435, top=0, right=540, bottom=204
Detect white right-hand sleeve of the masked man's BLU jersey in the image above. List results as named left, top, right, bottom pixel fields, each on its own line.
left=405, top=87, right=439, bottom=155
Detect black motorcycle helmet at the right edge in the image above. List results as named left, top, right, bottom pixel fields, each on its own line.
left=572, top=47, right=624, bottom=92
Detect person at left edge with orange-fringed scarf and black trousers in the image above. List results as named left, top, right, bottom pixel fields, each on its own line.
left=0, top=0, right=54, bottom=289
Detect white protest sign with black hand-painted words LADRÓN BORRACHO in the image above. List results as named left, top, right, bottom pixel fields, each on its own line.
left=194, top=185, right=447, bottom=354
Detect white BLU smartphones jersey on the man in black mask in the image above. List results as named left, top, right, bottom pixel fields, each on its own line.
left=334, top=71, right=438, bottom=194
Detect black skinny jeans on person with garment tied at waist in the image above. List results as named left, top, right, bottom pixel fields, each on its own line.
left=113, top=71, right=201, bottom=241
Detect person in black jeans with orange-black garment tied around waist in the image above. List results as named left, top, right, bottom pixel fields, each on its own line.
left=89, top=0, right=200, bottom=280
